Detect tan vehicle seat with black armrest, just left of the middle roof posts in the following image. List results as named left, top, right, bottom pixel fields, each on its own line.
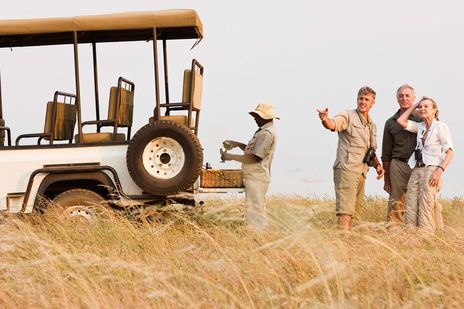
left=15, top=91, right=77, bottom=146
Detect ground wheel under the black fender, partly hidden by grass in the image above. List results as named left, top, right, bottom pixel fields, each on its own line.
left=48, top=189, right=108, bottom=221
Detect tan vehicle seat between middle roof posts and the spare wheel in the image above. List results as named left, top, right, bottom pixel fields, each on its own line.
left=75, top=77, right=135, bottom=143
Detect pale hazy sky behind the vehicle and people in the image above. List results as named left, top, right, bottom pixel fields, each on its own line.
left=0, top=0, right=464, bottom=197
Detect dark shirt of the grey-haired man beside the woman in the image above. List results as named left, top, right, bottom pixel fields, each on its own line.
left=382, top=110, right=422, bottom=162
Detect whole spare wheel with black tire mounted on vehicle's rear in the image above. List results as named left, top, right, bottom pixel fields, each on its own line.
left=126, top=121, right=203, bottom=196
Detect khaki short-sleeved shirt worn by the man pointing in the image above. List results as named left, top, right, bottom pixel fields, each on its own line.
left=333, top=109, right=377, bottom=175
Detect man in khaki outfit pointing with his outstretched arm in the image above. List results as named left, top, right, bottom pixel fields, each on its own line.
left=317, top=86, right=384, bottom=230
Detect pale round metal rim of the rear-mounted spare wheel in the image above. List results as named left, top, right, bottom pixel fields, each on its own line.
left=142, top=137, right=185, bottom=179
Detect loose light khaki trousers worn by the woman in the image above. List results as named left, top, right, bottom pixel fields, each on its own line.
left=404, top=166, right=442, bottom=233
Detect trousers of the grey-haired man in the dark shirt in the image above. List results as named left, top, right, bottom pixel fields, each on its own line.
left=387, top=159, right=412, bottom=223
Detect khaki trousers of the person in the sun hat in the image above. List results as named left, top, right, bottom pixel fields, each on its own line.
left=243, top=178, right=269, bottom=231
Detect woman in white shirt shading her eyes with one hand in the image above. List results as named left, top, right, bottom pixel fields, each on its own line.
left=397, top=97, right=453, bottom=232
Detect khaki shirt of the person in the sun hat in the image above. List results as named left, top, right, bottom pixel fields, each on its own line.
left=242, top=122, right=276, bottom=183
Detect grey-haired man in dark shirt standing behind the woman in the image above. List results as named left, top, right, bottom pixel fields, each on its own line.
left=382, top=84, right=421, bottom=223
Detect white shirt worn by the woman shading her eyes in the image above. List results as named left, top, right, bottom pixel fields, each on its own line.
left=406, top=120, right=454, bottom=168
